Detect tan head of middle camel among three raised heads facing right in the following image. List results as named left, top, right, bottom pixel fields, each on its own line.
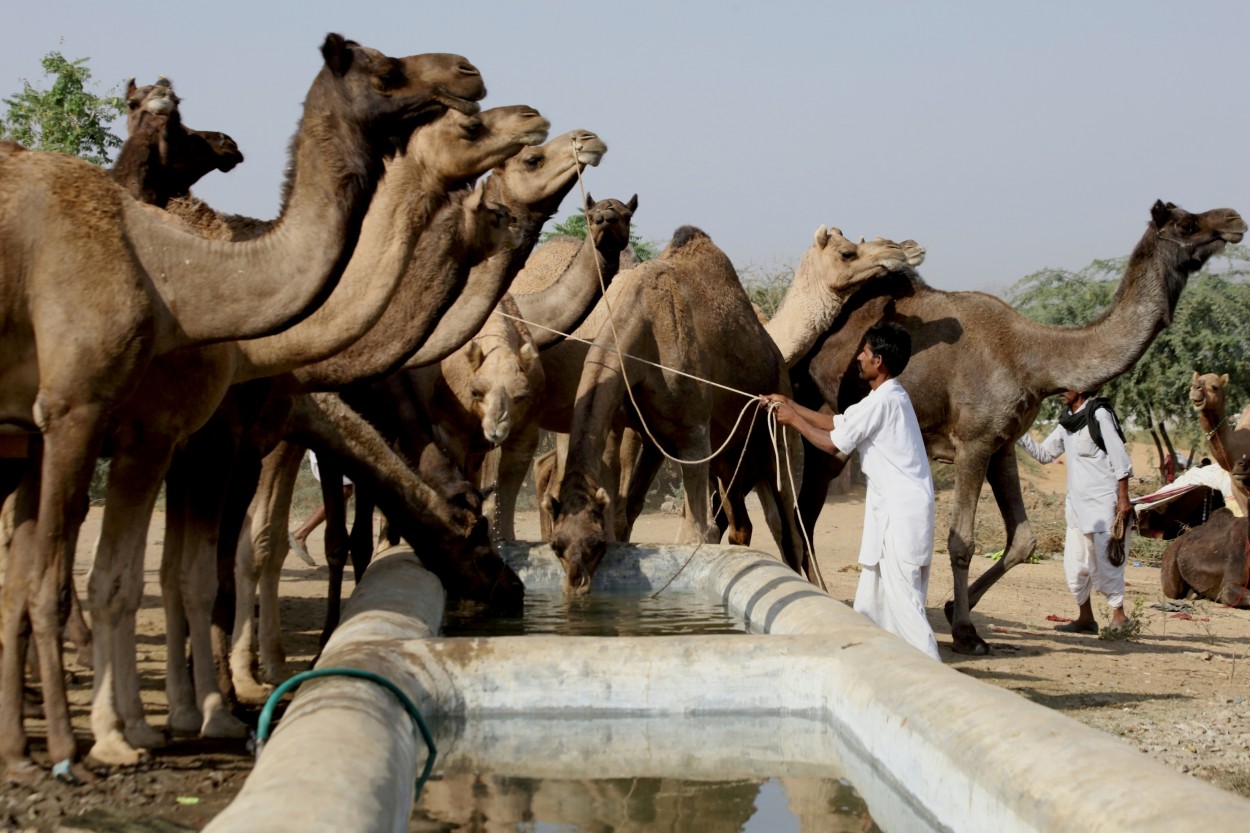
left=408, top=105, right=551, bottom=190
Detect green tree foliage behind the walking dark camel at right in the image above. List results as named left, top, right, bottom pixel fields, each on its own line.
left=1008, top=245, right=1250, bottom=442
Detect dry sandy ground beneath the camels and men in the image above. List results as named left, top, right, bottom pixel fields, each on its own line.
left=0, top=448, right=1250, bottom=830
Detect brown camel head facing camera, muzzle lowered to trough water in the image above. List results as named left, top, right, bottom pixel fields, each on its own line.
left=550, top=470, right=609, bottom=595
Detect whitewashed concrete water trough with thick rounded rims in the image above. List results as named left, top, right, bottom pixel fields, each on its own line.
left=206, top=544, right=1250, bottom=833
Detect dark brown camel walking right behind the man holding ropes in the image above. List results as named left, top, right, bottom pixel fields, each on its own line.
left=791, top=201, right=1246, bottom=654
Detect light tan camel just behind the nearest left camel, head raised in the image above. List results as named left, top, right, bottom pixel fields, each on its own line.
left=71, top=95, right=532, bottom=763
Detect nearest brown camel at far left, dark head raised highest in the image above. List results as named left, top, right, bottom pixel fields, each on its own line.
left=0, top=35, right=485, bottom=778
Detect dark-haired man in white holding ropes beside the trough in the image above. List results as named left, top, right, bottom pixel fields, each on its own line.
left=763, top=321, right=941, bottom=662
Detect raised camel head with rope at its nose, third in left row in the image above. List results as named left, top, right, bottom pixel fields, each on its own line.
left=488, top=130, right=608, bottom=215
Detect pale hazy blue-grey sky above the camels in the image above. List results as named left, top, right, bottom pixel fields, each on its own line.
left=0, top=0, right=1250, bottom=291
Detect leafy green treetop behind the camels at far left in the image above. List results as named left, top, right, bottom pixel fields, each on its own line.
left=0, top=51, right=126, bottom=165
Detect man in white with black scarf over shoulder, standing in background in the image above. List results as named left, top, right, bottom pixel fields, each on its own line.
left=1018, top=390, right=1133, bottom=634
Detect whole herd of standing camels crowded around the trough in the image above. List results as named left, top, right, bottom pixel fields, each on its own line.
left=0, top=34, right=1246, bottom=779
